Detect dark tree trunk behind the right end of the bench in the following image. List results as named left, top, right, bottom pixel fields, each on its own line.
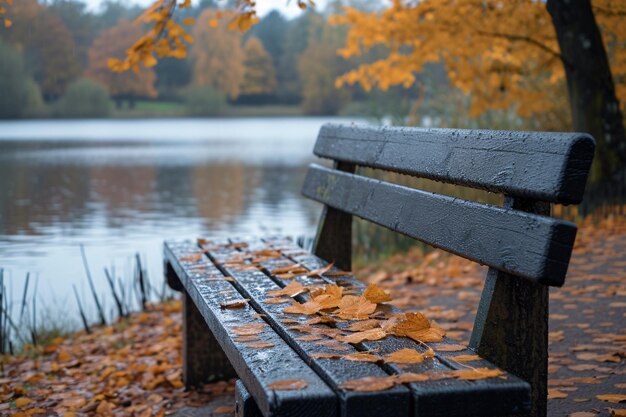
left=547, top=0, right=626, bottom=181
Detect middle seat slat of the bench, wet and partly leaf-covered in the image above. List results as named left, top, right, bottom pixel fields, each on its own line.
left=202, top=240, right=410, bottom=417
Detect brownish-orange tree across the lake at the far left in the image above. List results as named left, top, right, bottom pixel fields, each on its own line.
left=2, top=0, right=80, bottom=100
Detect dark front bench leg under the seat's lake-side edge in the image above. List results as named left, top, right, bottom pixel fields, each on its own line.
left=183, top=291, right=236, bottom=388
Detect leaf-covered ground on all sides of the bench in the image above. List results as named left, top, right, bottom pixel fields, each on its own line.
left=0, top=218, right=626, bottom=417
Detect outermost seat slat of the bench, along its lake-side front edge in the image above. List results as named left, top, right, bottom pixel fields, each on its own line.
left=164, top=242, right=338, bottom=417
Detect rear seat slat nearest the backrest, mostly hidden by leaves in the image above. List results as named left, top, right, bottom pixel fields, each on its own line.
left=224, top=237, right=530, bottom=417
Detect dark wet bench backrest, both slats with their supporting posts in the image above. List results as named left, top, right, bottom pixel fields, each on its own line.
left=303, top=121, right=595, bottom=416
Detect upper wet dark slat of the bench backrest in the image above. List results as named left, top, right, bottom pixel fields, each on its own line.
left=314, top=124, right=595, bottom=204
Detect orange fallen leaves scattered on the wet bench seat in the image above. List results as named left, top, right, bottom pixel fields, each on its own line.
left=197, top=239, right=506, bottom=391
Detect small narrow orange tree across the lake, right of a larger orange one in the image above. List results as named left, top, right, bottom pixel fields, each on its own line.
left=241, top=37, right=276, bottom=96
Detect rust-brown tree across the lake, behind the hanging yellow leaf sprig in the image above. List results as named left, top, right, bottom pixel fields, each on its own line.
left=87, top=20, right=157, bottom=107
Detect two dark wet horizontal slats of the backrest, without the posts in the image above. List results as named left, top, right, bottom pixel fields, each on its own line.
left=303, top=124, right=595, bottom=286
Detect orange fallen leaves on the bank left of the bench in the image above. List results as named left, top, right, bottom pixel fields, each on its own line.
left=0, top=302, right=233, bottom=417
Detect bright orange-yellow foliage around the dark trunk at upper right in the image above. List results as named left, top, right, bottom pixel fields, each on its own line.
left=332, top=0, right=626, bottom=117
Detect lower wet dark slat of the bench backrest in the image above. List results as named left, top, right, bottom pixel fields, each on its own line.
left=302, top=164, right=576, bottom=286
